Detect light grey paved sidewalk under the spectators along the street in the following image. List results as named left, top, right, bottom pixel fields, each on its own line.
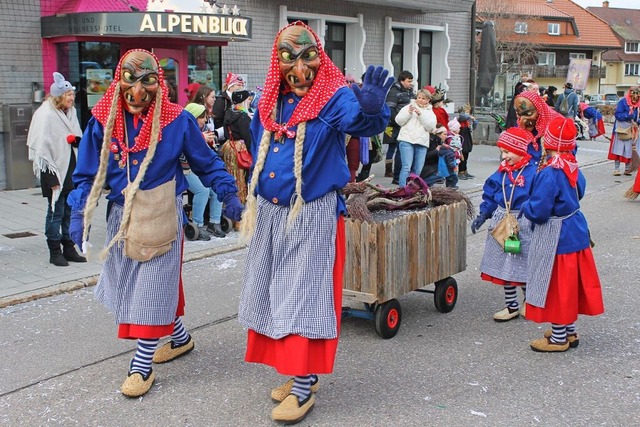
left=0, top=132, right=610, bottom=308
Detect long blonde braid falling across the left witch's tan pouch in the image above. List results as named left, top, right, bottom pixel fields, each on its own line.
left=100, top=87, right=162, bottom=259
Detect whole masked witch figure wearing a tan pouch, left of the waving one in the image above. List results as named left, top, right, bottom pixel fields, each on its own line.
left=67, top=49, right=242, bottom=397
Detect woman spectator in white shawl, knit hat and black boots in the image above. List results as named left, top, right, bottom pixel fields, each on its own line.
left=27, top=72, right=87, bottom=267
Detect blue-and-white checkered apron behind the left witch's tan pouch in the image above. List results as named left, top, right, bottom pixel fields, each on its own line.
left=95, top=196, right=183, bottom=325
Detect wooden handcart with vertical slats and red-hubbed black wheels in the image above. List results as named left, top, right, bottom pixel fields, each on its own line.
left=342, top=201, right=467, bottom=339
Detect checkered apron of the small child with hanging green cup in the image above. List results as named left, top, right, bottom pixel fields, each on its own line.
left=480, top=206, right=531, bottom=284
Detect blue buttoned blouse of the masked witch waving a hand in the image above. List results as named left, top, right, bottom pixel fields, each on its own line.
left=251, top=87, right=391, bottom=214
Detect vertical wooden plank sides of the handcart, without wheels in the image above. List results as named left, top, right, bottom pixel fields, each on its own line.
left=344, top=202, right=467, bottom=302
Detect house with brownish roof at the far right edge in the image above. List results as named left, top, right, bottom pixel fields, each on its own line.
left=587, top=1, right=640, bottom=96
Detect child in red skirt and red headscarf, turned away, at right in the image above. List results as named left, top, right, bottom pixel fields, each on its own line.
left=521, top=117, right=604, bottom=352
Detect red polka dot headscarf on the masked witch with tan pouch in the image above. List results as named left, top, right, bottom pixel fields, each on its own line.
left=91, top=49, right=182, bottom=152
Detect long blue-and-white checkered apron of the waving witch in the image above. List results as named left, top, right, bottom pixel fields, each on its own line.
left=238, top=192, right=338, bottom=339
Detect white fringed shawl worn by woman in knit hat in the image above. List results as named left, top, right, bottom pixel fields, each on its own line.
left=27, top=97, right=82, bottom=206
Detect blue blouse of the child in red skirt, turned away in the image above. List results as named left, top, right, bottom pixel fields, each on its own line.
left=521, top=166, right=589, bottom=254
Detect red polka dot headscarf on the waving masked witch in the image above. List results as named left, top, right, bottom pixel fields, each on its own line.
left=258, top=21, right=345, bottom=139
